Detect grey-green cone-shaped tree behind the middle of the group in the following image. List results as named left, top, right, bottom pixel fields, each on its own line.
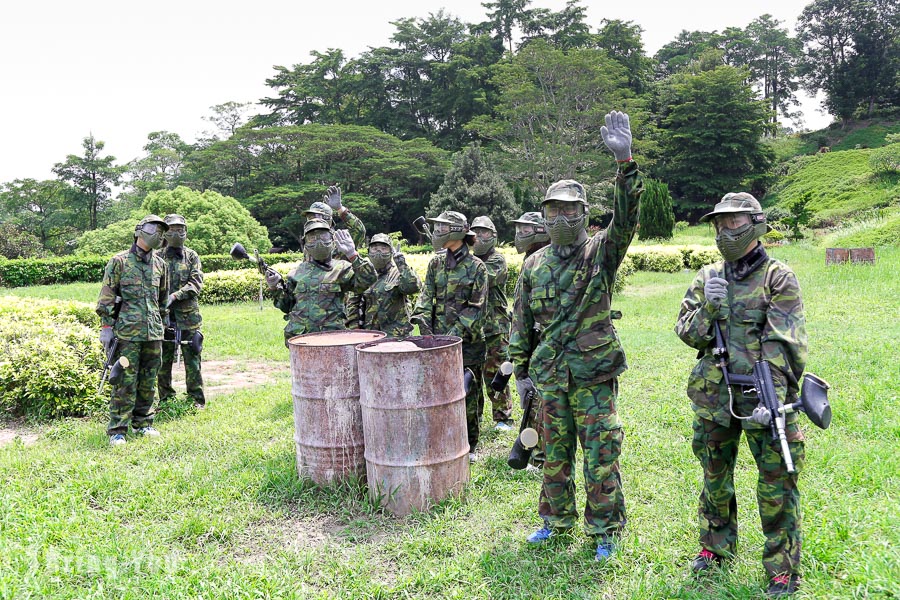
left=428, top=143, right=521, bottom=239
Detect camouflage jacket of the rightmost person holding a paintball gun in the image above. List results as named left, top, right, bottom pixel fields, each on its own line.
left=675, top=246, right=807, bottom=428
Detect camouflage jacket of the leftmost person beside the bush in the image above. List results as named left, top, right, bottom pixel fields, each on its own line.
left=97, top=244, right=169, bottom=342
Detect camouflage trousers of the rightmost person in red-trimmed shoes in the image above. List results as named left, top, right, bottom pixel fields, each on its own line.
left=692, top=415, right=806, bottom=577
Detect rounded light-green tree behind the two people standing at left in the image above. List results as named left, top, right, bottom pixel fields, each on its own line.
left=77, top=186, right=271, bottom=255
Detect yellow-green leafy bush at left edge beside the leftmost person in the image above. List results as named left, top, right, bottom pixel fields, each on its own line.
left=0, top=296, right=106, bottom=418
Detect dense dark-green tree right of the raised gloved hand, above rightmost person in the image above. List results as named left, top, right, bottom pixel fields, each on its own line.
left=657, top=65, right=772, bottom=209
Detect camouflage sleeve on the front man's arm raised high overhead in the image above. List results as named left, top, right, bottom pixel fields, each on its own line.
left=601, top=160, right=644, bottom=289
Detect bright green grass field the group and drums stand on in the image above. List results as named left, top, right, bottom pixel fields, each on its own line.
left=0, top=234, right=900, bottom=599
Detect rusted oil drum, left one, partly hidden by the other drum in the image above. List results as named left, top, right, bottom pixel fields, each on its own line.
left=288, top=329, right=385, bottom=485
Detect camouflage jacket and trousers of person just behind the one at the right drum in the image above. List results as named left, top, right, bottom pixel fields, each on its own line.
left=478, top=250, right=512, bottom=425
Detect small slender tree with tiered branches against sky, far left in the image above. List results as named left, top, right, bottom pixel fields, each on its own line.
left=53, top=134, right=124, bottom=229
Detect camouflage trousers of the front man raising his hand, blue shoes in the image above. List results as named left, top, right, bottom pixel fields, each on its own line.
left=538, top=378, right=626, bottom=538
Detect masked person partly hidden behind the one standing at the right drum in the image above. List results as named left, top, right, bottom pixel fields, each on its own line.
left=472, top=216, right=513, bottom=431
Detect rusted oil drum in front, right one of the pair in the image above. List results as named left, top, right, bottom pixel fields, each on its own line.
left=357, top=335, right=469, bottom=516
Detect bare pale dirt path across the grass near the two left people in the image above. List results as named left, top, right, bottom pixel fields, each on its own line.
left=0, top=360, right=291, bottom=448
